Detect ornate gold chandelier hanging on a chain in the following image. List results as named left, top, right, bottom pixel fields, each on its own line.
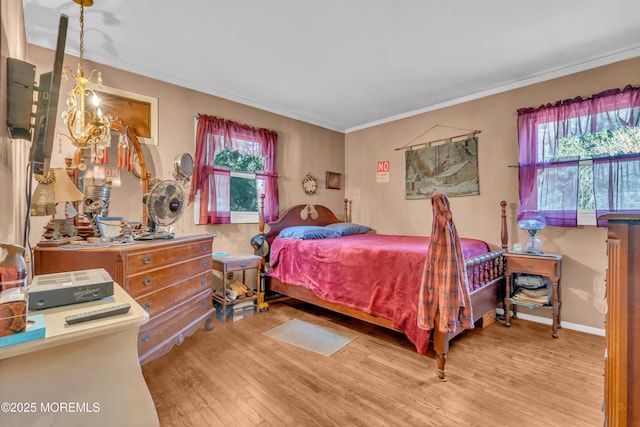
left=62, top=0, right=112, bottom=149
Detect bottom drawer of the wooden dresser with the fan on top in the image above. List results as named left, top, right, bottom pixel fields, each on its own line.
left=138, top=289, right=214, bottom=360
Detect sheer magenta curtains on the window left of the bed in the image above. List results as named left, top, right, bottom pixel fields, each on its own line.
left=190, top=114, right=279, bottom=224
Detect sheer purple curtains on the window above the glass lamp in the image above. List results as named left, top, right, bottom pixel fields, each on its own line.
left=518, top=86, right=640, bottom=227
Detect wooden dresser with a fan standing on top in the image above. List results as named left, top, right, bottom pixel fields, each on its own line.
left=34, top=234, right=215, bottom=364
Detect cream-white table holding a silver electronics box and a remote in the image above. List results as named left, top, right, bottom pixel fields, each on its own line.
left=0, top=284, right=159, bottom=427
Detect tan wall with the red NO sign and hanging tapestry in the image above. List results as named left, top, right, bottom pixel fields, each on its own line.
left=345, top=58, right=640, bottom=329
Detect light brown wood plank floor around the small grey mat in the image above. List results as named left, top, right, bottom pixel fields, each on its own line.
left=142, top=301, right=604, bottom=427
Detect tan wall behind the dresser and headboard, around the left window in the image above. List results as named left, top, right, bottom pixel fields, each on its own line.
left=27, top=45, right=344, bottom=254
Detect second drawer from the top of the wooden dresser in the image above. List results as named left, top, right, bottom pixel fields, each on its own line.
left=126, top=255, right=211, bottom=298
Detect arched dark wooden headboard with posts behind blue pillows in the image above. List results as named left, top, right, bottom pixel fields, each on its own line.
left=259, top=194, right=349, bottom=246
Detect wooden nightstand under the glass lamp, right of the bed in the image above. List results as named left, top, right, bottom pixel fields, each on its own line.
left=504, top=253, right=562, bottom=338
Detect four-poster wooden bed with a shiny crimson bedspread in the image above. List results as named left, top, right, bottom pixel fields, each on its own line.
left=255, top=199, right=507, bottom=380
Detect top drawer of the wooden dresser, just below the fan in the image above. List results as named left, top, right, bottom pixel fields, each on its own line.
left=126, top=239, right=212, bottom=274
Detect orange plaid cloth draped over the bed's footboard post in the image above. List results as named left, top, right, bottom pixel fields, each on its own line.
left=418, top=193, right=473, bottom=333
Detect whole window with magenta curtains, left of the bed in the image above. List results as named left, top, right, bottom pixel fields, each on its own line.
left=190, top=114, right=279, bottom=224
